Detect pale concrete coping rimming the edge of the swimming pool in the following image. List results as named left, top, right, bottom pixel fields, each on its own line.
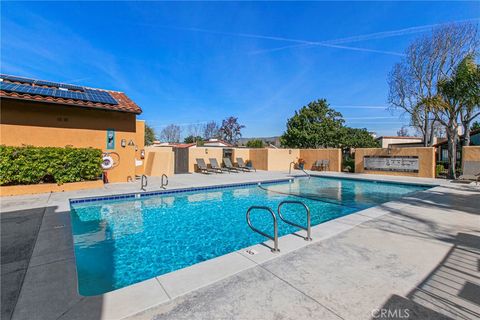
left=56, top=174, right=439, bottom=319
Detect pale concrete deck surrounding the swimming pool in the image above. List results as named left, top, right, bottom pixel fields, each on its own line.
left=1, top=171, right=480, bottom=319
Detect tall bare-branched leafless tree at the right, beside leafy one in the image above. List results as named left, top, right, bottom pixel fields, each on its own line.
left=388, top=23, right=478, bottom=146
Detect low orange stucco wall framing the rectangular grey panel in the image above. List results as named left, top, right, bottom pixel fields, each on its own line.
left=355, top=148, right=435, bottom=178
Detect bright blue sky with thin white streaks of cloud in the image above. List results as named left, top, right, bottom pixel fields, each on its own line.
left=1, top=1, right=480, bottom=137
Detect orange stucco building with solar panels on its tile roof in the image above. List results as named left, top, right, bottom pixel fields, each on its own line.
left=0, top=75, right=145, bottom=182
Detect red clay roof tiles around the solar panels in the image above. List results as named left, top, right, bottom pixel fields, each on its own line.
left=0, top=77, right=142, bottom=114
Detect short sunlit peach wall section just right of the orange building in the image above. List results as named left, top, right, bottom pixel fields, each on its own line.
left=145, top=147, right=175, bottom=177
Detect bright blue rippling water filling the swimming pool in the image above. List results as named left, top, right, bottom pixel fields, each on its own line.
left=71, top=177, right=426, bottom=296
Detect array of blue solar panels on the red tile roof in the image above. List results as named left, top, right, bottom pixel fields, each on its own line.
left=0, top=82, right=118, bottom=105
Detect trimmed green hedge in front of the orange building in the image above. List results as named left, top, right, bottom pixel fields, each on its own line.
left=0, top=145, right=102, bottom=186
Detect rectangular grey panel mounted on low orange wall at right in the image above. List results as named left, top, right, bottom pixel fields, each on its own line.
left=363, top=156, right=418, bottom=172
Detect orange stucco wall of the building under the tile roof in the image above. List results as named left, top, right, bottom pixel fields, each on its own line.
left=0, top=99, right=144, bottom=182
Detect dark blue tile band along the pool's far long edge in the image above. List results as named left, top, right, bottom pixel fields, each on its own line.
left=69, top=177, right=290, bottom=204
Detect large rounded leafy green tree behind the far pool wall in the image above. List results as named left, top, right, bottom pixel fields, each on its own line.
left=280, top=99, right=345, bottom=149
